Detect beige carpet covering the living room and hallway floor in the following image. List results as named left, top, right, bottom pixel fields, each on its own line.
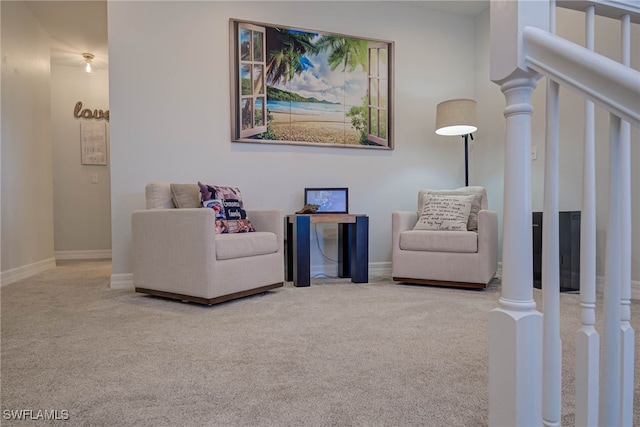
left=0, top=261, right=640, bottom=427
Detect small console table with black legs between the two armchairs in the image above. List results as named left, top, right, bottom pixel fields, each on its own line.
left=285, top=214, right=369, bottom=287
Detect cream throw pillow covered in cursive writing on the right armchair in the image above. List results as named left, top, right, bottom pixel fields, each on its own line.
left=413, top=194, right=474, bottom=231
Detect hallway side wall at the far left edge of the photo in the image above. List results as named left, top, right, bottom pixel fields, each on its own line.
left=0, top=2, right=55, bottom=284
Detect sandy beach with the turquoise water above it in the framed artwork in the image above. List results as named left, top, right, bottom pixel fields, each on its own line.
left=268, top=102, right=360, bottom=145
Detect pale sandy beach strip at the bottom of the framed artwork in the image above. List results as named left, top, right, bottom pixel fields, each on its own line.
left=270, top=112, right=360, bottom=144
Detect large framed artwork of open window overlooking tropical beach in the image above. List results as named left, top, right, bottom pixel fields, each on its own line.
left=230, top=19, right=393, bottom=150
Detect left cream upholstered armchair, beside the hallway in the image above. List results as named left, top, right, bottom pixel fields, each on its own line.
left=131, top=182, right=284, bottom=304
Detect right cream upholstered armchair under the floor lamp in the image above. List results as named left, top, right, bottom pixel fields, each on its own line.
left=392, top=186, right=498, bottom=288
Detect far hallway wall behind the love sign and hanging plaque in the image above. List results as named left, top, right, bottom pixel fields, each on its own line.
left=51, top=61, right=111, bottom=259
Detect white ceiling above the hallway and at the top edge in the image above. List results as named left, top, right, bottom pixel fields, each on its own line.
left=26, top=0, right=489, bottom=72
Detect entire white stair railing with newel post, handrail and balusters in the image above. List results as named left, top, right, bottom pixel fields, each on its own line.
left=489, top=0, right=640, bottom=426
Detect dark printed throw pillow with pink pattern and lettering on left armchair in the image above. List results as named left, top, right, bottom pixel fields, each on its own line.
left=198, top=182, right=256, bottom=233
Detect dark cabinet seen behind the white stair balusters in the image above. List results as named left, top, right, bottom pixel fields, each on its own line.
left=533, top=211, right=580, bottom=292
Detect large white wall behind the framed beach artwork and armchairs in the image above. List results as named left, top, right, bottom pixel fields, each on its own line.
left=108, top=2, right=484, bottom=283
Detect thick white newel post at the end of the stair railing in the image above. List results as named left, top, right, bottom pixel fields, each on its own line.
left=489, top=0, right=549, bottom=426
